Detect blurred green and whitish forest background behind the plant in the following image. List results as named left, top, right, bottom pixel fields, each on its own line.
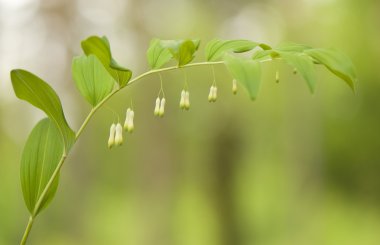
left=0, top=0, right=380, bottom=245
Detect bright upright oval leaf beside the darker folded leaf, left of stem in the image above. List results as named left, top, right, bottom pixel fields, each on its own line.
left=72, top=55, right=115, bottom=106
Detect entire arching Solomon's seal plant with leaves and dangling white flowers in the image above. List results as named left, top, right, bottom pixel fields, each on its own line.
left=11, top=36, right=356, bottom=244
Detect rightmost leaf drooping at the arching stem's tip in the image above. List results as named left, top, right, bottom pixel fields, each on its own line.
left=304, top=49, right=357, bottom=90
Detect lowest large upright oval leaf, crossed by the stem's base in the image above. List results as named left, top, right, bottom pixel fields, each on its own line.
left=20, top=118, right=64, bottom=217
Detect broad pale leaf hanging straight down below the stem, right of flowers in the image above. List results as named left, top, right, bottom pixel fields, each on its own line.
left=224, top=54, right=261, bottom=100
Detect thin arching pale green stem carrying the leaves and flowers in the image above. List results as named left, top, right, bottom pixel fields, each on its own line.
left=20, top=61, right=235, bottom=245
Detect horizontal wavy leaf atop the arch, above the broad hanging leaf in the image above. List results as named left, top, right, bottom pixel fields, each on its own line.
left=205, top=39, right=259, bottom=61
